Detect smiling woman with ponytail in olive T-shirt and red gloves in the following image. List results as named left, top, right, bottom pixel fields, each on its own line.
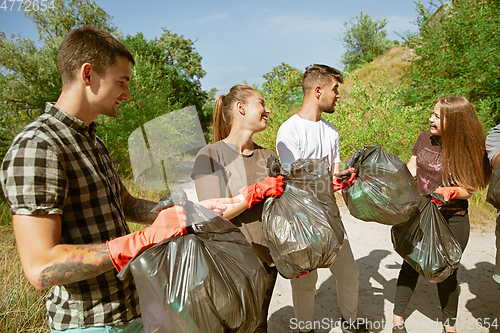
left=192, top=85, right=283, bottom=332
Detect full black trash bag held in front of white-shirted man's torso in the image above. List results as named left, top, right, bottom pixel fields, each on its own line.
left=262, top=156, right=345, bottom=279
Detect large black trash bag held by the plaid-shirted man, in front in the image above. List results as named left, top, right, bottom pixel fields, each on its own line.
left=119, top=188, right=266, bottom=333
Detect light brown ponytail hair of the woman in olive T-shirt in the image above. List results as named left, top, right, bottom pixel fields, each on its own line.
left=212, top=84, right=255, bottom=142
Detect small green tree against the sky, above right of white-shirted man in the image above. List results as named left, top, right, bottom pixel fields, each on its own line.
left=340, top=12, right=391, bottom=72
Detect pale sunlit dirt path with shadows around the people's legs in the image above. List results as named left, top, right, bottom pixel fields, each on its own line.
left=269, top=207, right=500, bottom=333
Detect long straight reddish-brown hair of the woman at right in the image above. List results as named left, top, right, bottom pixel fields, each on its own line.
left=439, top=97, right=491, bottom=193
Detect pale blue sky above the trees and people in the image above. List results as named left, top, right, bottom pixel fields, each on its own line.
left=0, top=0, right=429, bottom=94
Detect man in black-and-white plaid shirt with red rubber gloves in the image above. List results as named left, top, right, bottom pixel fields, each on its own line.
left=0, top=27, right=232, bottom=332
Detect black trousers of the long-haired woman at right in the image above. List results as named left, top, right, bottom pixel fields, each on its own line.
left=394, top=212, right=470, bottom=326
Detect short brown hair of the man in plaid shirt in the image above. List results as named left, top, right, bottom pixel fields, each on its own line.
left=57, top=26, right=135, bottom=85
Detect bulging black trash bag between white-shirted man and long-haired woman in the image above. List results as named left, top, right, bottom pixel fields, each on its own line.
left=342, top=146, right=420, bottom=225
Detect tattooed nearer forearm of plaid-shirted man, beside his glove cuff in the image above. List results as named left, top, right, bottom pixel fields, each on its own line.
left=40, top=244, right=114, bottom=288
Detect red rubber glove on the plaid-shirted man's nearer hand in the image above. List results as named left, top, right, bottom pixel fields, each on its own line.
left=106, top=206, right=187, bottom=272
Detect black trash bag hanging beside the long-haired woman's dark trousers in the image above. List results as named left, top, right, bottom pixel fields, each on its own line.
left=391, top=195, right=462, bottom=283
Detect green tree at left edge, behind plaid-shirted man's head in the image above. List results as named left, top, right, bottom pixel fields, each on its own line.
left=0, top=0, right=117, bottom=163
